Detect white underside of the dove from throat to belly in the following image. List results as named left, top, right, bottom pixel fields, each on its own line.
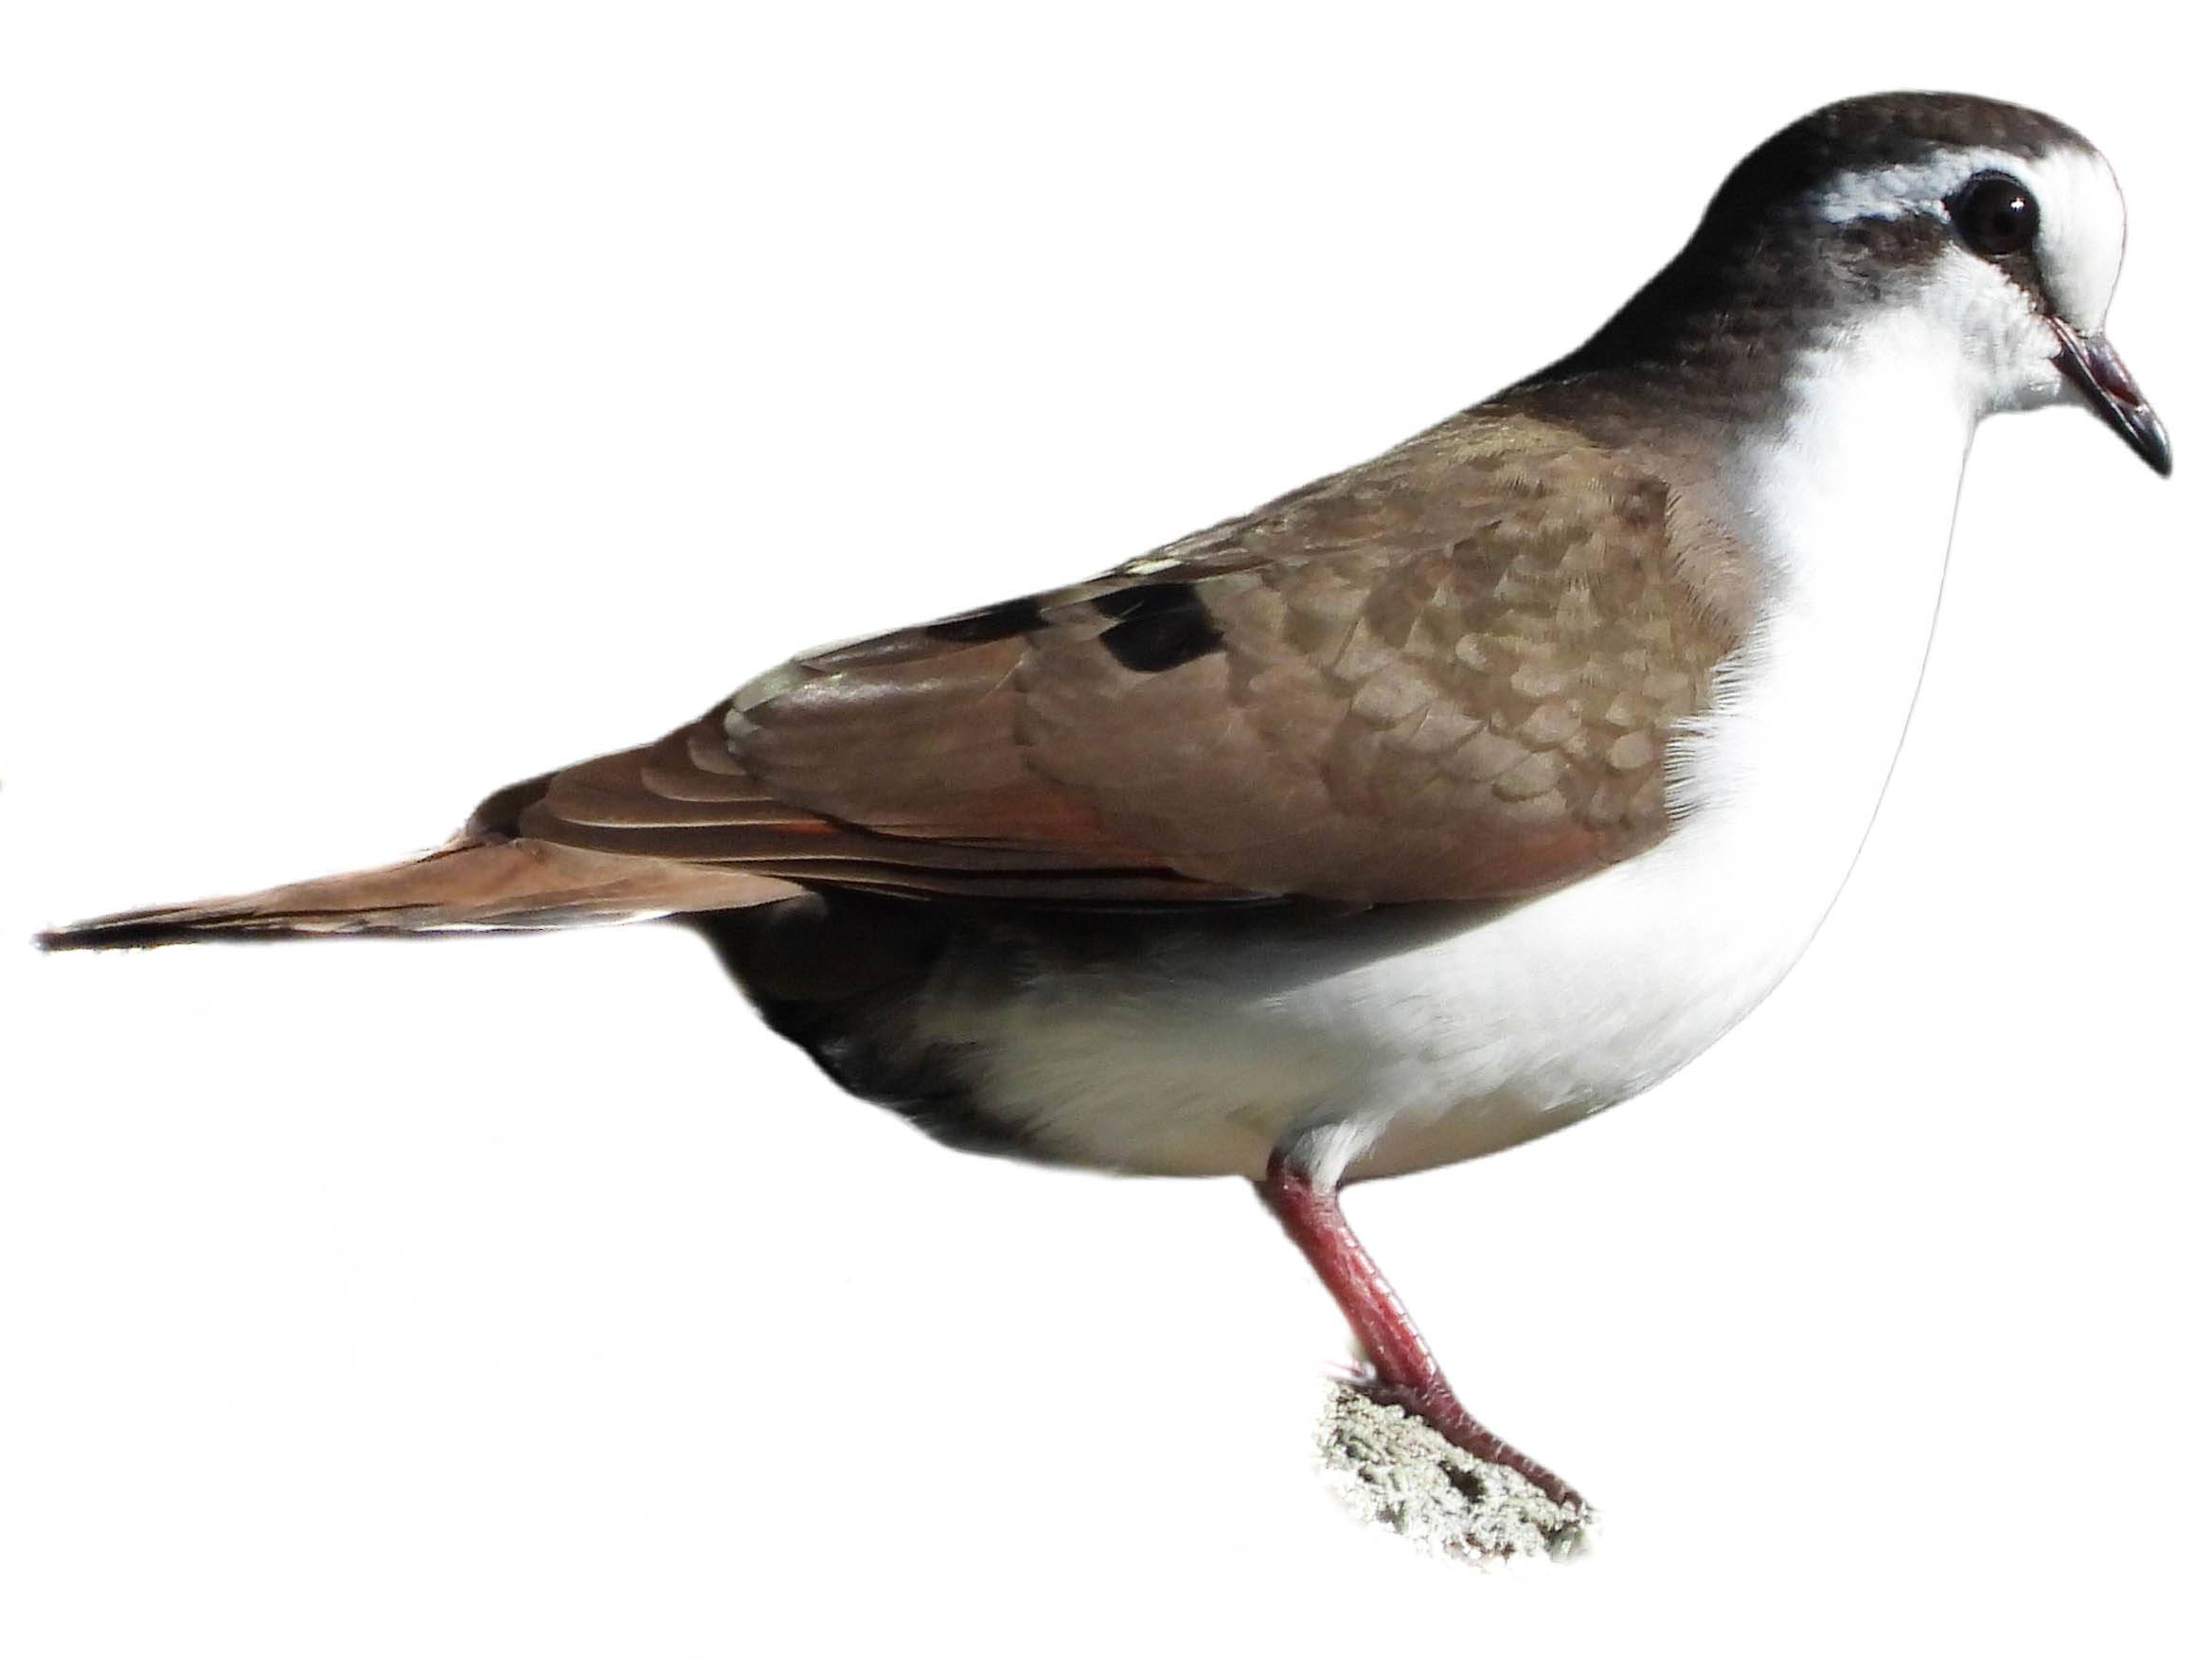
left=947, top=318, right=1973, bottom=1174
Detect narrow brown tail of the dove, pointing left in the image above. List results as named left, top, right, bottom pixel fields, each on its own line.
left=38, top=836, right=798, bottom=951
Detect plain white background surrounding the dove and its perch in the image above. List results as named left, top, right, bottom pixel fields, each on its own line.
left=0, top=5, right=2212, bottom=1659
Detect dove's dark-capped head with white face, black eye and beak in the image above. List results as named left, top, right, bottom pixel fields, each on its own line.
left=1578, top=93, right=2172, bottom=473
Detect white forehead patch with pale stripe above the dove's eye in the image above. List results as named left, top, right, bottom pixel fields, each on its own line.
left=1816, top=146, right=2128, bottom=334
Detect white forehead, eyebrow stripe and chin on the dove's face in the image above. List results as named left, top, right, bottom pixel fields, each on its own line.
left=1818, top=149, right=2128, bottom=414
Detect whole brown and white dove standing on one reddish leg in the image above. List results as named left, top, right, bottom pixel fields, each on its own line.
left=40, top=93, right=2172, bottom=1548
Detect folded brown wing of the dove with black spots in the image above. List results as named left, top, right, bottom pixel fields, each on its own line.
left=492, top=409, right=1740, bottom=902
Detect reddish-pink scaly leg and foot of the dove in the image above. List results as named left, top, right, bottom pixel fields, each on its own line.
left=1258, top=1148, right=1586, bottom=1513
